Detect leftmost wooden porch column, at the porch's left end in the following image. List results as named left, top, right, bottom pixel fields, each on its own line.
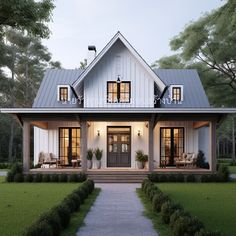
left=23, top=121, right=30, bottom=173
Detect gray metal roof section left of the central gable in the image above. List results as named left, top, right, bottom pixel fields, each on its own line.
left=33, top=69, right=83, bottom=108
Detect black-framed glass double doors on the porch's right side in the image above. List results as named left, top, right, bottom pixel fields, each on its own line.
left=160, top=128, right=184, bottom=166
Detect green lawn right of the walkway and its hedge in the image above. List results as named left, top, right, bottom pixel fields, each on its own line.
left=157, top=182, right=236, bottom=236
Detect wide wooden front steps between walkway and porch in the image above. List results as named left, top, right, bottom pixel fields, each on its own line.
left=87, top=171, right=148, bottom=183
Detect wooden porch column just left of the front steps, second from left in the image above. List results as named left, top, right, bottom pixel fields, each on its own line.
left=80, top=121, right=88, bottom=171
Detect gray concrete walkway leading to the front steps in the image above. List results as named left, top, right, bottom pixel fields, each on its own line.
left=77, top=184, right=158, bottom=236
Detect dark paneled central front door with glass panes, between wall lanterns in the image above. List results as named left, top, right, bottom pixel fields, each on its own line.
left=107, top=126, right=131, bottom=167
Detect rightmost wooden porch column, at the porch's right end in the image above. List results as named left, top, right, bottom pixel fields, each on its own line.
left=209, top=121, right=216, bottom=172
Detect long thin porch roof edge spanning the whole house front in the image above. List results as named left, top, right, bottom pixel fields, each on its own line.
left=0, top=107, right=236, bottom=114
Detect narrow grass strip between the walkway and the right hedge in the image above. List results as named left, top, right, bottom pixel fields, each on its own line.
left=136, top=189, right=173, bottom=236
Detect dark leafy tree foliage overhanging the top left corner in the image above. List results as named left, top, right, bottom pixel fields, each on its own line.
left=0, top=0, right=54, bottom=38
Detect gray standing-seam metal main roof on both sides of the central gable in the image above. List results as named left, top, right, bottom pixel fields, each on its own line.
left=33, top=69, right=210, bottom=109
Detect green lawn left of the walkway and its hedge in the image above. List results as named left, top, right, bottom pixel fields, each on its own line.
left=0, top=177, right=79, bottom=236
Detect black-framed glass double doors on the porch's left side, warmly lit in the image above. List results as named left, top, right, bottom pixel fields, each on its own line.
left=59, top=128, right=80, bottom=165
